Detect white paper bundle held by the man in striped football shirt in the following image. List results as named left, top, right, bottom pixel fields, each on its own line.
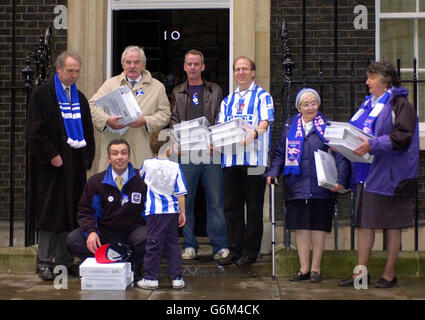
left=210, top=118, right=254, bottom=153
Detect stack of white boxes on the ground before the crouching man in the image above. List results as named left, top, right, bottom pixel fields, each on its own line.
left=80, top=258, right=133, bottom=290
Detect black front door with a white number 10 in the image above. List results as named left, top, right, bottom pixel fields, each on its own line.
left=112, top=9, right=229, bottom=236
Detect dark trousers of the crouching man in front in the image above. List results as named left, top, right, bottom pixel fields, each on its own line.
left=66, top=224, right=146, bottom=271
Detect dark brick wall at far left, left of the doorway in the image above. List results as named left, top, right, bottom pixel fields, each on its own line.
left=0, top=0, right=67, bottom=217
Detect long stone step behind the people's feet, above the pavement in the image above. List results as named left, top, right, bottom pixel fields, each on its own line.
left=0, top=246, right=425, bottom=279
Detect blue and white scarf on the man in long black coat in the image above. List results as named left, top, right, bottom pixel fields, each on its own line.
left=55, top=73, right=87, bottom=149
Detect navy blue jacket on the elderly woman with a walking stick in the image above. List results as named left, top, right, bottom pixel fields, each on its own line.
left=265, top=116, right=350, bottom=201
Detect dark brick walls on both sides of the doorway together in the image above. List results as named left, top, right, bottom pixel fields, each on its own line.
left=0, top=0, right=425, bottom=222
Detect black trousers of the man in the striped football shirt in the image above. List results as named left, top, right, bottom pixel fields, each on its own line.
left=224, top=166, right=266, bottom=260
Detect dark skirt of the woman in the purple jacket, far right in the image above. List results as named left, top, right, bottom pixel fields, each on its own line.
left=355, top=184, right=414, bottom=229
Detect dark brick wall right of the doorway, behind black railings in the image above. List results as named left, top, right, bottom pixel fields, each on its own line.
left=271, top=0, right=425, bottom=220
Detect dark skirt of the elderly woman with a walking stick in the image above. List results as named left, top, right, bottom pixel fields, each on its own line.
left=285, top=199, right=334, bottom=232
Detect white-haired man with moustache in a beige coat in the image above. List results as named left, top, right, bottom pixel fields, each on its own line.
left=89, top=46, right=171, bottom=171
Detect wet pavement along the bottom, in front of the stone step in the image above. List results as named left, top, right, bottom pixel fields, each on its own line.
left=0, top=274, right=425, bottom=300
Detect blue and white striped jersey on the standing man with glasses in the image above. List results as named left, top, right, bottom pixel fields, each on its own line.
left=217, top=81, right=274, bottom=167
